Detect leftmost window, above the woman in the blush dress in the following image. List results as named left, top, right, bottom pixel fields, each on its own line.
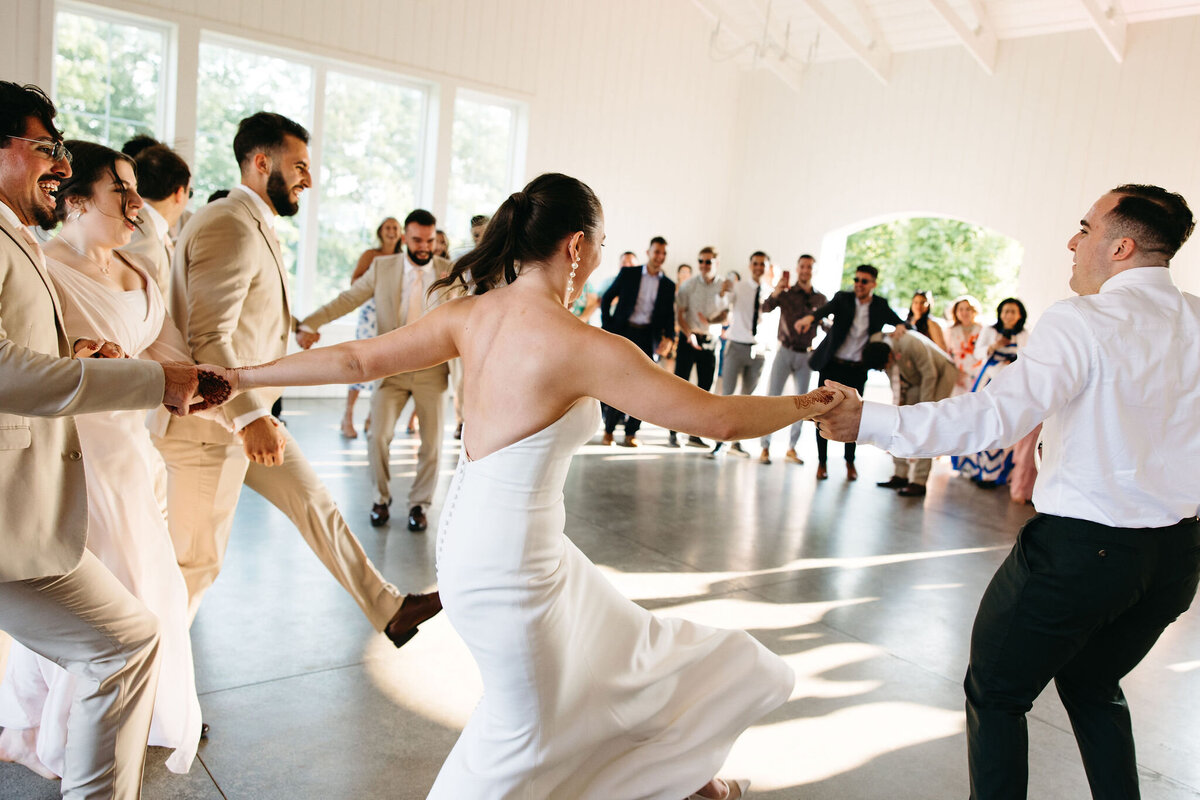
left=54, top=6, right=170, bottom=149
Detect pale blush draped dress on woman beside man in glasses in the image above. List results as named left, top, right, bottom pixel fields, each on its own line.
left=0, top=258, right=200, bottom=775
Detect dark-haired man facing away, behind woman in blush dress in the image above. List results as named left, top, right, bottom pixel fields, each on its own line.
left=121, top=136, right=192, bottom=297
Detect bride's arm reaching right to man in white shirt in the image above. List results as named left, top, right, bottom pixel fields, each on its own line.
left=576, top=329, right=842, bottom=441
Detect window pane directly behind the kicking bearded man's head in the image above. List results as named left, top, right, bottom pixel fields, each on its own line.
left=192, top=41, right=313, bottom=281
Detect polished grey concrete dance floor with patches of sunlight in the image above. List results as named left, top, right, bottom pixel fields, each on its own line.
left=0, top=401, right=1200, bottom=800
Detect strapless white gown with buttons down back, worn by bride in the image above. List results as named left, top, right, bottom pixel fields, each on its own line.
left=428, top=399, right=794, bottom=800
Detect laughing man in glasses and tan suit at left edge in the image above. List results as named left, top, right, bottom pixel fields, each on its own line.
left=0, top=82, right=205, bottom=800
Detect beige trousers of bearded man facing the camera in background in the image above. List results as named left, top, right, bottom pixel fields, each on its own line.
left=367, top=363, right=450, bottom=511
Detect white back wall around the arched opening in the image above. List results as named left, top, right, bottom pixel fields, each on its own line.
left=725, top=17, right=1200, bottom=313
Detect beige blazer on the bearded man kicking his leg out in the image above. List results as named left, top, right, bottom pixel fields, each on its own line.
left=150, top=191, right=294, bottom=444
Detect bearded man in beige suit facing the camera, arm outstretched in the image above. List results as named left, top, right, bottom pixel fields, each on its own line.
left=296, top=209, right=450, bottom=533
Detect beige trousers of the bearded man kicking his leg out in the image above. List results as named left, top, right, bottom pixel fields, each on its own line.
left=155, top=428, right=403, bottom=631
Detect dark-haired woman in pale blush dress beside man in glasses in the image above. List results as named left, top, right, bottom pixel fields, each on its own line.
left=0, top=142, right=202, bottom=777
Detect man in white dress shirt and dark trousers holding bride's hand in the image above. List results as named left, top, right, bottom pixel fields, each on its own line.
left=817, top=185, right=1200, bottom=800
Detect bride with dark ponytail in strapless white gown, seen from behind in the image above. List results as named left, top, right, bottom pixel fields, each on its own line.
left=223, top=174, right=836, bottom=800
